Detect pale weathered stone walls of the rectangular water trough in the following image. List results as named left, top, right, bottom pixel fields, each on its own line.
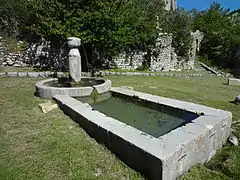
left=54, top=88, right=232, bottom=180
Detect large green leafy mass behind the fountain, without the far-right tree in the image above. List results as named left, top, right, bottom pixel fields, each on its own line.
left=0, top=0, right=193, bottom=69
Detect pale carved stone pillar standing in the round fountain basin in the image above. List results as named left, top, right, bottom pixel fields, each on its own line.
left=68, top=37, right=82, bottom=83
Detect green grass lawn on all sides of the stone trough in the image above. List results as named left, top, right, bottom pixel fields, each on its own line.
left=0, top=76, right=240, bottom=180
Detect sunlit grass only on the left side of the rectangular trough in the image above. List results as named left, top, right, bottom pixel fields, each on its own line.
left=0, top=78, right=141, bottom=180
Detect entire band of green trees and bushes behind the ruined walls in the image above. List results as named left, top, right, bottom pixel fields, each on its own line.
left=0, top=0, right=240, bottom=72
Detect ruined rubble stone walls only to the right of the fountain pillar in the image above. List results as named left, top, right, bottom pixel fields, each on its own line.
left=113, top=30, right=204, bottom=72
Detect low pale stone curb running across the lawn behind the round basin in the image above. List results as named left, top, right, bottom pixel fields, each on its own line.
left=0, top=71, right=204, bottom=78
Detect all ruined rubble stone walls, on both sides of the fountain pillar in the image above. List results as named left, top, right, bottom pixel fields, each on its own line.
left=0, top=31, right=203, bottom=72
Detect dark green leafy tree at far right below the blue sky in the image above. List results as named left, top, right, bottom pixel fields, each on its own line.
left=193, top=2, right=240, bottom=67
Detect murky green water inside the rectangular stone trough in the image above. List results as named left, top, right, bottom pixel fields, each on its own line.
left=91, top=96, right=198, bottom=137
